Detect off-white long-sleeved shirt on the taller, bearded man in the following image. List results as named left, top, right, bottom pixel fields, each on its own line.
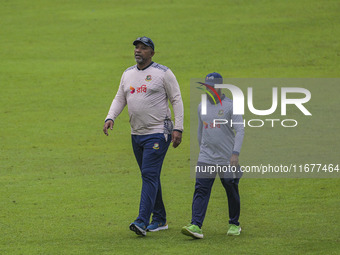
left=106, top=62, right=184, bottom=135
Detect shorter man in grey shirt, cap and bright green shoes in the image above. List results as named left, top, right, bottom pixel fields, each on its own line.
left=181, top=72, right=244, bottom=239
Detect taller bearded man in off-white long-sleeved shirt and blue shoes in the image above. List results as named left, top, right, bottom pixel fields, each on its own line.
left=103, top=36, right=184, bottom=236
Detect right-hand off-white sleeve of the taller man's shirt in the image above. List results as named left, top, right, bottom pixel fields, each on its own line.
left=164, top=69, right=184, bottom=131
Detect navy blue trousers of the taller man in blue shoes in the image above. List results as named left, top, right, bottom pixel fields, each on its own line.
left=131, top=133, right=171, bottom=226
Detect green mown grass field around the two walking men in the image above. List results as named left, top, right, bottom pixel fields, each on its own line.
left=0, top=0, right=340, bottom=254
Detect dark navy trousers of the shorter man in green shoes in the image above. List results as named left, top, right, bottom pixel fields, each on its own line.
left=191, top=164, right=240, bottom=228
